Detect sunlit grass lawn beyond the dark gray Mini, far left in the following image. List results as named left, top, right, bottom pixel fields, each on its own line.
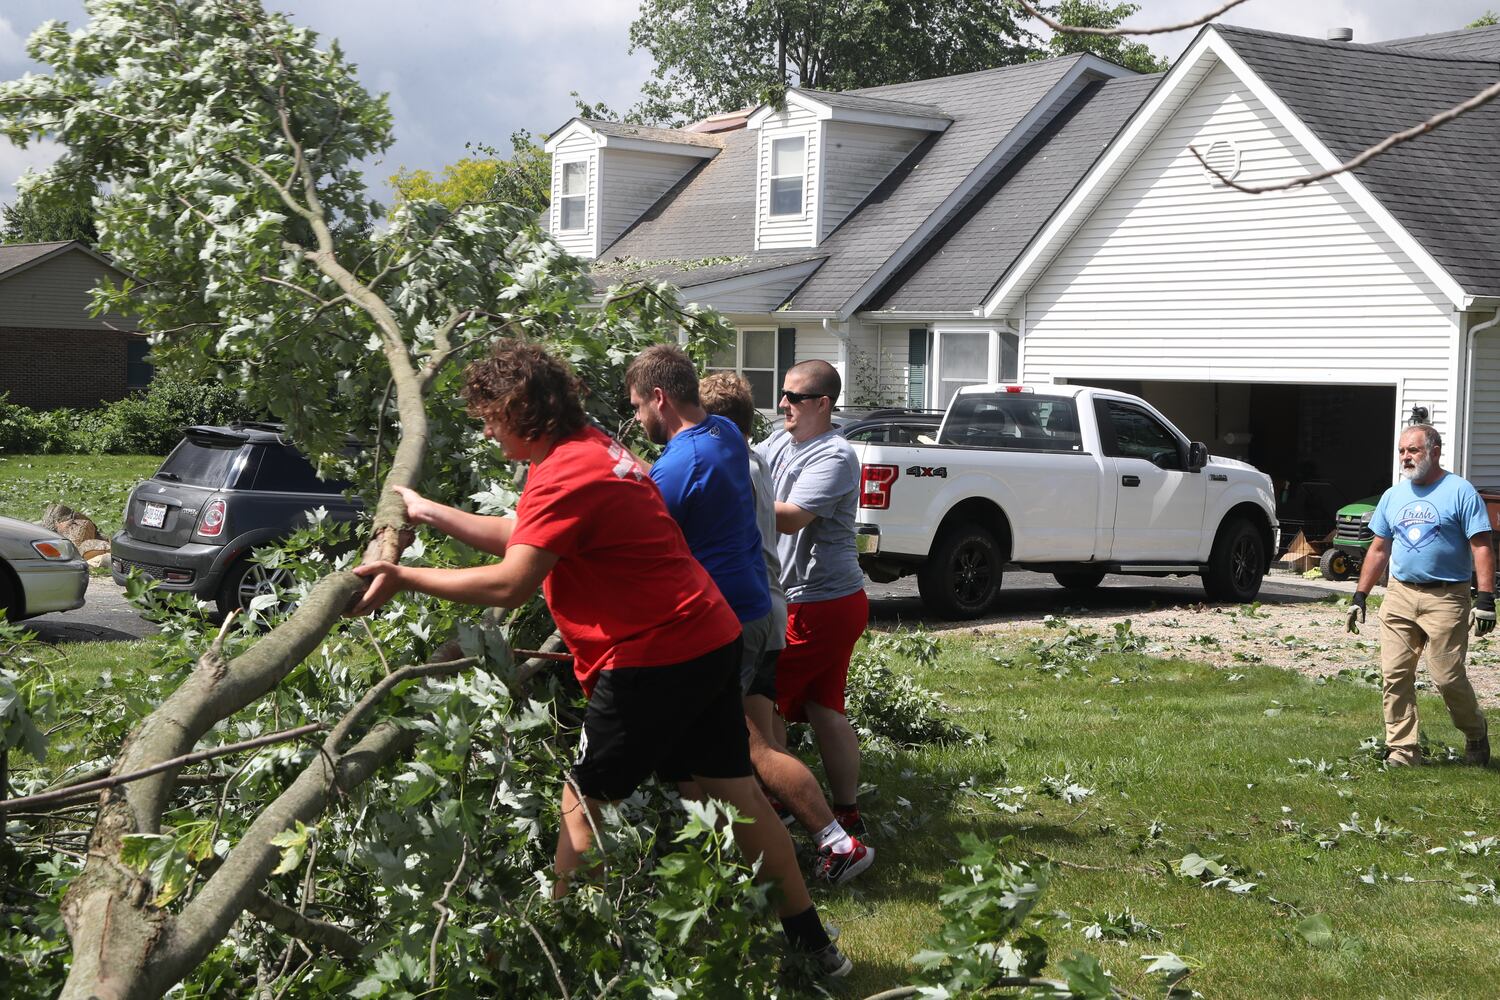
left=0, top=454, right=162, bottom=538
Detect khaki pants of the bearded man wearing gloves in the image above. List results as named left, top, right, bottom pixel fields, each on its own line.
left=1380, top=580, right=1487, bottom=750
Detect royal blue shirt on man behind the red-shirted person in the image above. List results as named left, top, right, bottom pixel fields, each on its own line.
left=651, top=414, right=771, bottom=622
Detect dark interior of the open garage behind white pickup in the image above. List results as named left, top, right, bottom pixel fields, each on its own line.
left=1070, top=379, right=1397, bottom=546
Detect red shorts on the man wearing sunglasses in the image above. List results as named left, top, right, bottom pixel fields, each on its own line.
left=776, top=589, right=870, bottom=723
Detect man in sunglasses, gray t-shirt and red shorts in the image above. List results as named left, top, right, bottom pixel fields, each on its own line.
left=756, top=361, right=870, bottom=835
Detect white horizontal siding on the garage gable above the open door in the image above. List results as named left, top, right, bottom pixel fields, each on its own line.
left=1022, top=66, right=1457, bottom=443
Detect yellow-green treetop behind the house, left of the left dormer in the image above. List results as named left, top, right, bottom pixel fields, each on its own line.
left=390, top=129, right=552, bottom=211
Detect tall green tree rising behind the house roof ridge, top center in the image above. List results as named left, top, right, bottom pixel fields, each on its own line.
left=630, top=0, right=1038, bottom=124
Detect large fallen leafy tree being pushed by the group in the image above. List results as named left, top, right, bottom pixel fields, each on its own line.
left=0, top=0, right=732, bottom=1000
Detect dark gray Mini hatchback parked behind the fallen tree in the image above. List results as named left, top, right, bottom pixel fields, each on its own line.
left=110, top=423, right=365, bottom=615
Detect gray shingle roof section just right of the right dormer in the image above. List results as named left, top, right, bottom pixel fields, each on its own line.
left=788, top=55, right=1080, bottom=312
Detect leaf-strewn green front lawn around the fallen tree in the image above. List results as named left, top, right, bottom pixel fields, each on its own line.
left=14, top=620, right=1500, bottom=1000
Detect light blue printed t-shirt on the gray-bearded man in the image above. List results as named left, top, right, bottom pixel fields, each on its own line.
left=1370, top=472, right=1490, bottom=583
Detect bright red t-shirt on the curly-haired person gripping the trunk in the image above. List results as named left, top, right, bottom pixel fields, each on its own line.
left=510, top=427, right=740, bottom=693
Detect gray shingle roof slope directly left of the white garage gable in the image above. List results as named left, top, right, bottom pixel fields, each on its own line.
left=864, top=75, right=1161, bottom=312
